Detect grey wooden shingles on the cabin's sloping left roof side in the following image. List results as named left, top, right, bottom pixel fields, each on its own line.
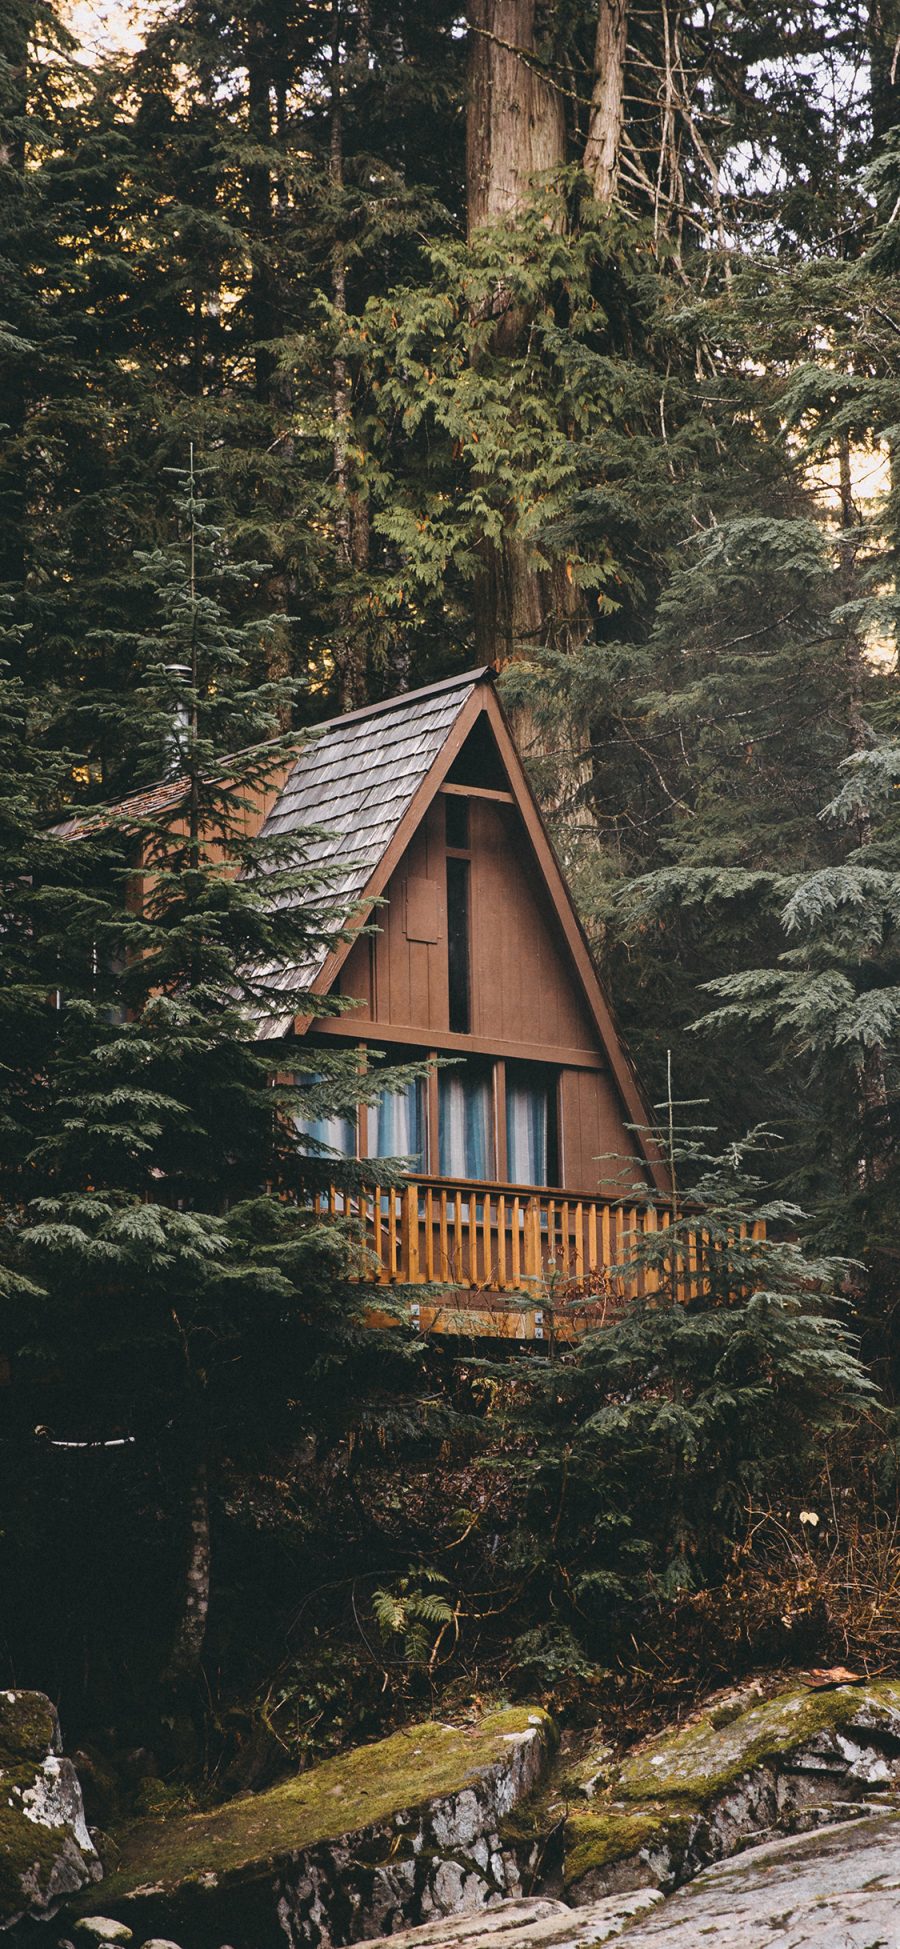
left=257, top=669, right=487, bottom=1037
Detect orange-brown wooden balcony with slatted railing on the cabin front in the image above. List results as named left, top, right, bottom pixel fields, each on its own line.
left=305, top=1177, right=764, bottom=1341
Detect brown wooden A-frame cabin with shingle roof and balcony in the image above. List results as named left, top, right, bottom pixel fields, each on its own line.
left=249, top=670, right=685, bottom=1339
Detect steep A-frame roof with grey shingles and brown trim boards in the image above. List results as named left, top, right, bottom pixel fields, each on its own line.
left=257, top=669, right=668, bottom=1191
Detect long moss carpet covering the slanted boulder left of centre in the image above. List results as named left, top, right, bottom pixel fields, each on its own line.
left=94, top=1705, right=551, bottom=1904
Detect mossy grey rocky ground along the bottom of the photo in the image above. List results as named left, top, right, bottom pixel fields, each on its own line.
left=8, top=1680, right=900, bottom=1949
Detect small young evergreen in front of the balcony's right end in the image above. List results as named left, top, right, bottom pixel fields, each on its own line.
left=481, top=1134, right=873, bottom=1653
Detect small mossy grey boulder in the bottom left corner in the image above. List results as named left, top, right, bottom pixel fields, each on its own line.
left=0, top=1692, right=103, bottom=1930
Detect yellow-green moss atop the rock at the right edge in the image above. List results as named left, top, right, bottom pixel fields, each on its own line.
left=616, top=1682, right=900, bottom=1805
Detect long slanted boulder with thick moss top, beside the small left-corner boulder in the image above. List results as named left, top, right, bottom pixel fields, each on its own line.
left=68, top=1705, right=555, bottom=1949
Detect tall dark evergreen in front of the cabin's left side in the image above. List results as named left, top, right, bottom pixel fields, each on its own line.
left=4, top=472, right=430, bottom=1722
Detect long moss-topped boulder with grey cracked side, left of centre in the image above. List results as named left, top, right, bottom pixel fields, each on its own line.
left=78, top=1707, right=553, bottom=1949
